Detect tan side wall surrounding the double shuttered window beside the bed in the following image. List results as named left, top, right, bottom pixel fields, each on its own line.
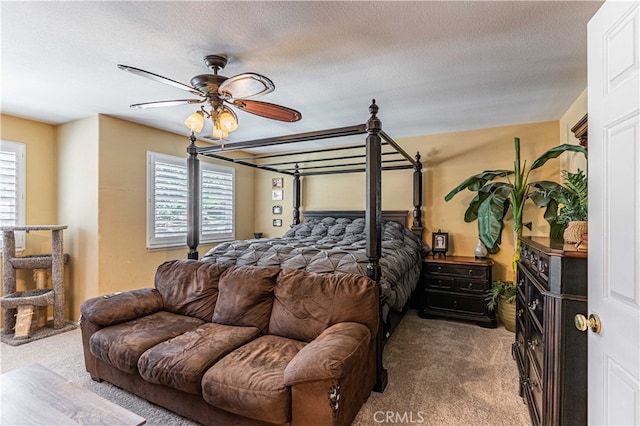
left=97, top=116, right=253, bottom=302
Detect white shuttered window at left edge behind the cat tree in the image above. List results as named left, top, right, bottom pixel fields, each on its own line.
left=0, top=141, right=26, bottom=250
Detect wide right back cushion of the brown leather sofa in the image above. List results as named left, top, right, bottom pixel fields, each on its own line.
left=269, top=269, right=379, bottom=342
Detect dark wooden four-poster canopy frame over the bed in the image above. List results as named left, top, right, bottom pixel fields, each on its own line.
left=187, top=99, right=423, bottom=392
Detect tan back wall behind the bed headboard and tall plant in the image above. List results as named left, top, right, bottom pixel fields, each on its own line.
left=255, top=121, right=560, bottom=279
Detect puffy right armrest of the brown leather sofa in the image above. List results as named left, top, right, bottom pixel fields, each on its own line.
left=284, top=322, right=372, bottom=386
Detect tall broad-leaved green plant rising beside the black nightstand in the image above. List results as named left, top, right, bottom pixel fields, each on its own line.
left=444, top=137, right=587, bottom=276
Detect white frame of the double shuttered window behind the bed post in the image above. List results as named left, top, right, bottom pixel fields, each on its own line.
left=146, top=151, right=236, bottom=251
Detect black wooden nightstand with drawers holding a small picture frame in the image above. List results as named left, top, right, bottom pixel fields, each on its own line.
left=420, top=256, right=497, bottom=328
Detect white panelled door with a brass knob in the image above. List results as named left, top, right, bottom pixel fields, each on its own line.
left=588, top=1, right=640, bottom=425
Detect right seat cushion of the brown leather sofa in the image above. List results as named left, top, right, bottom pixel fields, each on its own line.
left=202, top=336, right=306, bottom=423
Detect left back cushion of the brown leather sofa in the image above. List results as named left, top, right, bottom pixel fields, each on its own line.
left=155, top=259, right=227, bottom=322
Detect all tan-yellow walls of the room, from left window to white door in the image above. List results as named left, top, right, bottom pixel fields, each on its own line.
left=1, top=91, right=586, bottom=320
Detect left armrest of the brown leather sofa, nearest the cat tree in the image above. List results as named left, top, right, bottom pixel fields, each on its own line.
left=80, top=288, right=164, bottom=326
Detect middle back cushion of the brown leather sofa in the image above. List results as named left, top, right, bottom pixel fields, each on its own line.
left=213, top=265, right=280, bottom=334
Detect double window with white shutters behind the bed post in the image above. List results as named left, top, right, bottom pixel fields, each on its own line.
left=147, top=152, right=235, bottom=249
